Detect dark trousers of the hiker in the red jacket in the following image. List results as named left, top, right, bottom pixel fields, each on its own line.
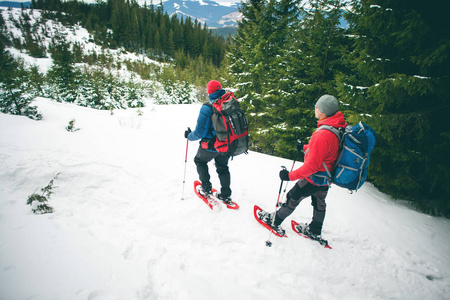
left=275, top=179, right=329, bottom=234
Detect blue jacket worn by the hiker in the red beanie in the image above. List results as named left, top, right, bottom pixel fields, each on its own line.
left=188, top=89, right=225, bottom=141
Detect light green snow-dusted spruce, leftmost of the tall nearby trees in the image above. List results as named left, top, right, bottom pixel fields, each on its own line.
left=229, top=0, right=294, bottom=154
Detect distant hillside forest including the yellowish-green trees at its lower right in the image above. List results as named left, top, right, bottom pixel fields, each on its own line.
left=27, top=0, right=229, bottom=90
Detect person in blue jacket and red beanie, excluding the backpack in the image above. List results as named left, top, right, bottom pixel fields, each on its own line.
left=184, top=80, right=231, bottom=203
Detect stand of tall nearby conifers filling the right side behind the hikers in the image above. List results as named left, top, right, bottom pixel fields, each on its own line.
left=228, top=0, right=450, bottom=216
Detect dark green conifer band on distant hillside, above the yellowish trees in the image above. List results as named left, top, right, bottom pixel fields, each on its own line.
left=31, top=0, right=227, bottom=67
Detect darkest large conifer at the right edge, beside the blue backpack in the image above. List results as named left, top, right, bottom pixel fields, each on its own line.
left=338, top=0, right=450, bottom=215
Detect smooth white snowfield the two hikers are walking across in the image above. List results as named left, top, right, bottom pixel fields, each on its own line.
left=0, top=98, right=450, bottom=300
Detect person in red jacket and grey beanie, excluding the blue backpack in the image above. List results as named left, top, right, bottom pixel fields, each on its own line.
left=260, top=95, right=347, bottom=239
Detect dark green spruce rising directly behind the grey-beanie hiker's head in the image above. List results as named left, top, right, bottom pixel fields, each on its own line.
left=280, top=0, right=349, bottom=153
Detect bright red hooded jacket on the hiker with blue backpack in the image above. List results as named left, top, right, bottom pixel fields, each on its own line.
left=289, top=111, right=347, bottom=183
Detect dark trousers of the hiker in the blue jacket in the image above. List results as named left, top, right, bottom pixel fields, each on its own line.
left=194, top=146, right=231, bottom=197
